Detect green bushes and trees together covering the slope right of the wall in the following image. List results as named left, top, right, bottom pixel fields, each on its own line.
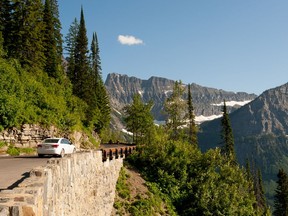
left=125, top=82, right=271, bottom=216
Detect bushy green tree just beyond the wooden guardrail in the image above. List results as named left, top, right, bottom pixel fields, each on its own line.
left=124, top=94, right=154, bottom=144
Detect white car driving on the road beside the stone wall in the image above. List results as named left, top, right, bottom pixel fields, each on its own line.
left=37, top=138, right=76, bottom=157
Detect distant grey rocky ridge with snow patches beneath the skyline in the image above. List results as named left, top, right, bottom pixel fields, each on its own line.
left=105, top=73, right=257, bottom=129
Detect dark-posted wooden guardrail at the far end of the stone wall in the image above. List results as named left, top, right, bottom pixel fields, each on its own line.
left=99, top=142, right=136, bottom=162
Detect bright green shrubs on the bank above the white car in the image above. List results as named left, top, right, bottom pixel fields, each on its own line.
left=0, top=55, right=87, bottom=129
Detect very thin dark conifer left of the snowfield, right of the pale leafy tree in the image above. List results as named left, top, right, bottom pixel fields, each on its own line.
left=187, top=84, right=198, bottom=146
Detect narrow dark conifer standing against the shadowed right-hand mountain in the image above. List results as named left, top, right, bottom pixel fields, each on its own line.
left=221, top=100, right=236, bottom=162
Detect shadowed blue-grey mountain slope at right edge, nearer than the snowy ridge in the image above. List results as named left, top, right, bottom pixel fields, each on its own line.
left=198, top=83, right=288, bottom=196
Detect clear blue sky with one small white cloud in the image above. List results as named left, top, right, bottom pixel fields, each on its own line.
left=58, top=0, right=288, bottom=94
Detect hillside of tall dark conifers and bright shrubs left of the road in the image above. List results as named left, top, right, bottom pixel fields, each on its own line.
left=0, top=0, right=110, bottom=138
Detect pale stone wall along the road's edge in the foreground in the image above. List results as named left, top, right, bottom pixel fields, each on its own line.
left=0, top=151, right=123, bottom=216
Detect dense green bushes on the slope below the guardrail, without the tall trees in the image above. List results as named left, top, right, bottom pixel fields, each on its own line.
left=129, top=125, right=257, bottom=215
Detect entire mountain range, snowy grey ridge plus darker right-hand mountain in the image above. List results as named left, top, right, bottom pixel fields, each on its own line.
left=105, top=73, right=288, bottom=204
